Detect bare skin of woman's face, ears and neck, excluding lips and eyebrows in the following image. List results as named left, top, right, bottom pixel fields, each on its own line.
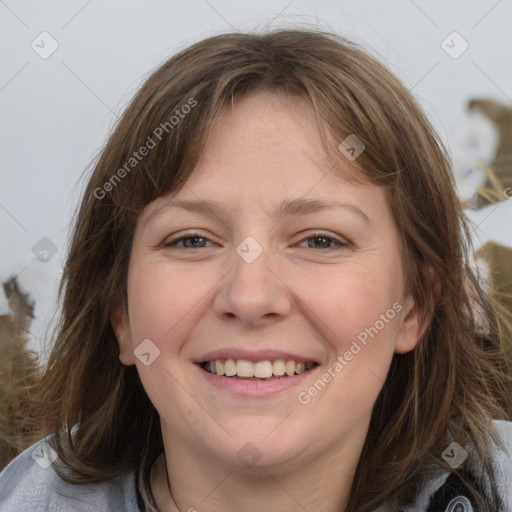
left=112, top=92, right=425, bottom=512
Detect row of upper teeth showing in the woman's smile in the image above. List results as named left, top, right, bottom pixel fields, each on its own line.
left=206, top=359, right=315, bottom=379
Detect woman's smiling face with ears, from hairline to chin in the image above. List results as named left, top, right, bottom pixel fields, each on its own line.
left=113, top=93, right=421, bottom=468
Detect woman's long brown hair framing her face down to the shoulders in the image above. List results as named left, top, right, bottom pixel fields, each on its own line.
left=30, top=29, right=511, bottom=512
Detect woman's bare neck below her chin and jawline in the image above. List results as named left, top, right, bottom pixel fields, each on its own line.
left=152, top=418, right=367, bottom=512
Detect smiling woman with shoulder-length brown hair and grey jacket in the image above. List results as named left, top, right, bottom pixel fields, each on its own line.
left=0, top=30, right=512, bottom=512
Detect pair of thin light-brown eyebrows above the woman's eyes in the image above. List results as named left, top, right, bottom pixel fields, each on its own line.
left=146, top=198, right=371, bottom=223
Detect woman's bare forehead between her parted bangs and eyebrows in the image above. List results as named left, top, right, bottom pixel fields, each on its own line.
left=182, top=91, right=369, bottom=194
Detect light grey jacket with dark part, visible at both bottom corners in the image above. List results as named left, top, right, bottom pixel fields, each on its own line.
left=0, top=420, right=512, bottom=512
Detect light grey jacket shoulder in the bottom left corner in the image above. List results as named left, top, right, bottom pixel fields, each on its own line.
left=0, top=438, right=140, bottom=512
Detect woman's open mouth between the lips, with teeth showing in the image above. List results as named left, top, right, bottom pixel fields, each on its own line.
left=199, top=358, right=318, bottom=381
